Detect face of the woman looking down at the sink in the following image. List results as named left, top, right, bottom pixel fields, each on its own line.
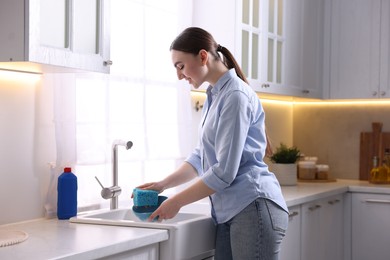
left=171, top=50, right=207, bottom=89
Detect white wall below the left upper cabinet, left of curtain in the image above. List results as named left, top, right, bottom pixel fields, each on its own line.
left=0, top=72, right=55, bottom=224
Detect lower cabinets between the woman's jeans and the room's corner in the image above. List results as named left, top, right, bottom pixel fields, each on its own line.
left=280, top=194, right=344, bottom=260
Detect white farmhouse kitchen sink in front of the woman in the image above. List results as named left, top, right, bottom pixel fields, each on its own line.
left=70, top=208, right=215, bottom=260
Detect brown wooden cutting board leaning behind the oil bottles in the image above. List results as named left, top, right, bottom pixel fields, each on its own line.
left=359, top=122, right=390, bottom=180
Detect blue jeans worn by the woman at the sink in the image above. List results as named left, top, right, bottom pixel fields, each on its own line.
left=215, top=198, right=288, bottom=260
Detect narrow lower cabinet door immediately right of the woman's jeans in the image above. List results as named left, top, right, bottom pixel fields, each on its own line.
left=280, top=206, right=301, bottom=260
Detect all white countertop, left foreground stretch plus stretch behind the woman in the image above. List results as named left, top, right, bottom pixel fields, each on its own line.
left=0, top=180, right=390, bottom=260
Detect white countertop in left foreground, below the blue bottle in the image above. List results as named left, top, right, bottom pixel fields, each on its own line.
left=0, top=219, right=168, bottom=260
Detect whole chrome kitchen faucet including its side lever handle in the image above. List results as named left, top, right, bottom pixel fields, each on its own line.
left=95, top=140, right=133, bottom=210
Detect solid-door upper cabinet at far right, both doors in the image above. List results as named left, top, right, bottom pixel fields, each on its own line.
left=324, top=0, right=390, bottom=99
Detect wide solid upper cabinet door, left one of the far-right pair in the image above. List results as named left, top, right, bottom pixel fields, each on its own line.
left=325, top=0, right=380, bottom=98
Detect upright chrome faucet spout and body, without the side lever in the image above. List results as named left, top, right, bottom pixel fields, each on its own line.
left=110, top=140, right=133, bottom=209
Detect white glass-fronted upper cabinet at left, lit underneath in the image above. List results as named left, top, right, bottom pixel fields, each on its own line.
left=0, top=0, right=111, bottom=73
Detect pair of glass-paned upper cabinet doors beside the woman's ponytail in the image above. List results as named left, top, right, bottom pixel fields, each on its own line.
left=241, top=0, right=284, bottom=84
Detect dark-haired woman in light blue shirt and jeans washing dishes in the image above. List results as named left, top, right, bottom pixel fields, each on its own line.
left=139, top=27, right=288, bottom=260
